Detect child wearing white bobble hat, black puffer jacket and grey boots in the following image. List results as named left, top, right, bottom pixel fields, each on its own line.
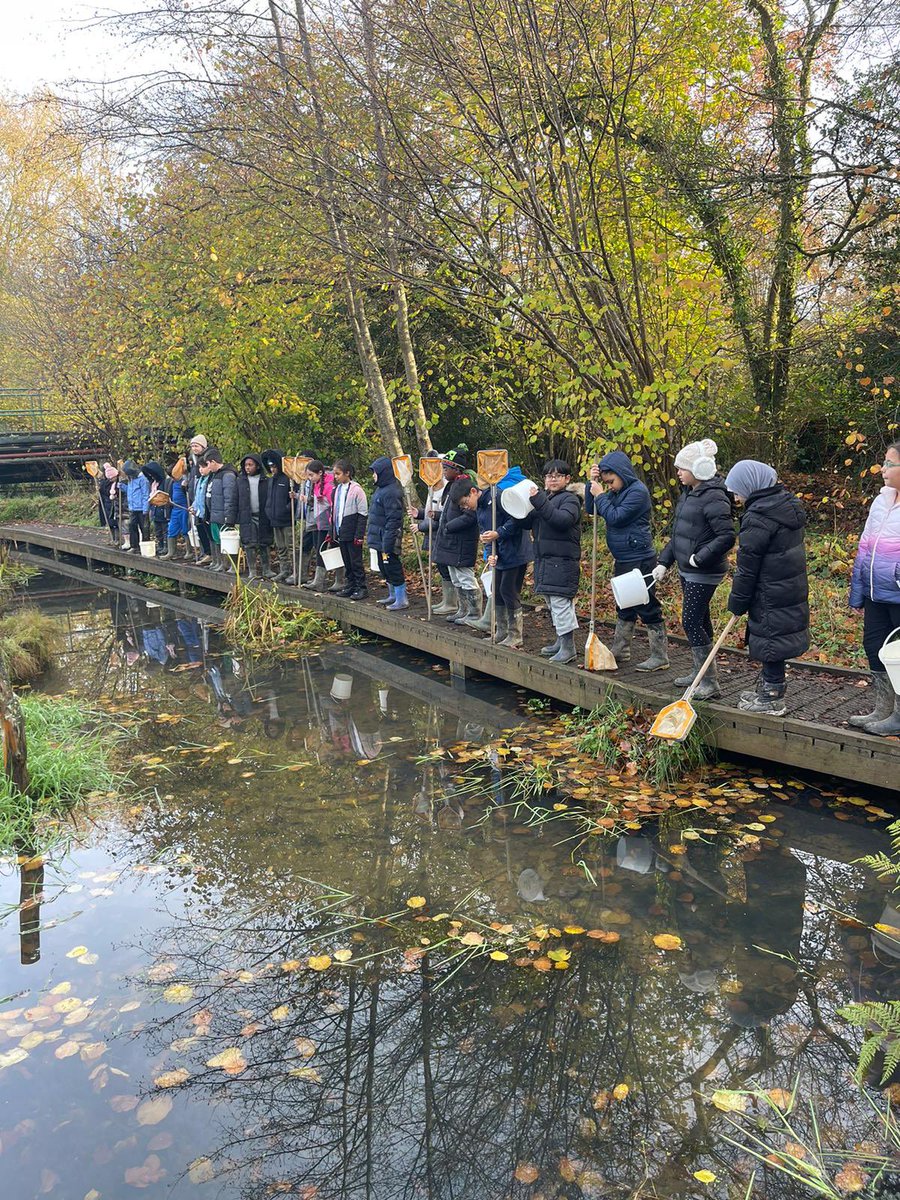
left=653, top=438, right=734, bottom=700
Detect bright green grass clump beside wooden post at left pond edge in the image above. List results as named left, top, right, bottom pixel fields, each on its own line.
left=0, top=695, right=125, bottom=850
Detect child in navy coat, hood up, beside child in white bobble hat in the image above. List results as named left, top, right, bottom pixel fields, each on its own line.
left=584, top=450, right=668, bottom=671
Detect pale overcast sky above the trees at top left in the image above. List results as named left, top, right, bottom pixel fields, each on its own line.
left=0, top=0, right=190, bottom=92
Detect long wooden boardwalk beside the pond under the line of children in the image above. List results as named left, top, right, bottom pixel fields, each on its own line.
left=0, top=524, right=900, bottom=791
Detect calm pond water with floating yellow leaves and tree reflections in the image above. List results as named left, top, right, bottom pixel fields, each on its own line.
left=0, top=592, right=900, bottom=1200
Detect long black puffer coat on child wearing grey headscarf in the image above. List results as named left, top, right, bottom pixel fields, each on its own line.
left=728, top=484, right=809, bottom=662
